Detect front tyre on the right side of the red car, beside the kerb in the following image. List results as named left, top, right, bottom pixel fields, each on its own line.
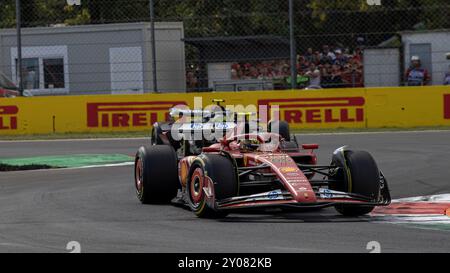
left=330, top=151, right=380, bottom=216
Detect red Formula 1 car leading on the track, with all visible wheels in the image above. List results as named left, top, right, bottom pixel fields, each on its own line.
left=135, top=123, right=391, bottom=218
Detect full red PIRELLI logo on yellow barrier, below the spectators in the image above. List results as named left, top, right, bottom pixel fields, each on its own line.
left=258, top=97, right=366, bottom=125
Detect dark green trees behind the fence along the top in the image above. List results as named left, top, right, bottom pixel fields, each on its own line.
left=0, top=0, right=450, bottom=40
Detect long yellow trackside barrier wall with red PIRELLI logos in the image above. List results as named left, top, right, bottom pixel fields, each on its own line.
left=0, top=86, right=450, bottom=135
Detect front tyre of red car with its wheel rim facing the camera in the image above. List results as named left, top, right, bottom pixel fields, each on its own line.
left=186, top=154, right=239, bottom=218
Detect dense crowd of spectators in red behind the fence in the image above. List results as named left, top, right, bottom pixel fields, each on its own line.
left=231, top=45, right=364, bottom=88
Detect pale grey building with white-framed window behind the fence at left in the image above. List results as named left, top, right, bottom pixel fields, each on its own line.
left=0, top=22, right=186, bottom=95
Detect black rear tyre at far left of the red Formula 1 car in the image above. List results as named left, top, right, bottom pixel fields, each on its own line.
left=134, top=145, right=179, bottom=204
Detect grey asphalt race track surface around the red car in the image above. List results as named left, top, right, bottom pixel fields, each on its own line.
left=0, top=131, right=450, bottom=253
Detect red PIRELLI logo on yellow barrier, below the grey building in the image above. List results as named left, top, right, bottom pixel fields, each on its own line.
left=86, top=101, right=186, bottom=128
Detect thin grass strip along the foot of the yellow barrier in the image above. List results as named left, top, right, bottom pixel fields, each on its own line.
left=0, top=126, right=450, bottom=141
